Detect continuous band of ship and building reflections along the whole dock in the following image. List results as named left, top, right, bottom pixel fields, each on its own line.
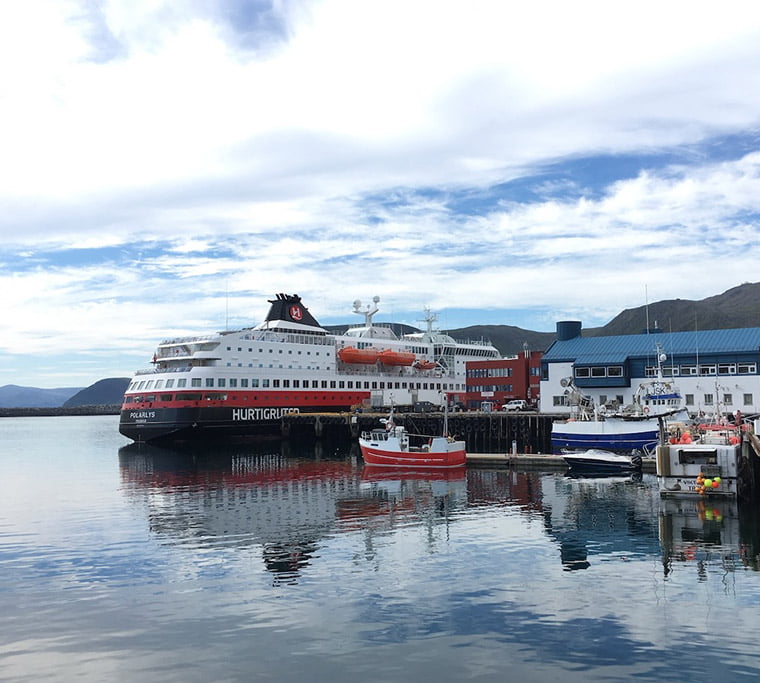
left=120, top=442, right=760, bottom=585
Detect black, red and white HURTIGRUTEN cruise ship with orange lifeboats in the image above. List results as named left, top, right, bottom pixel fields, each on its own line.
left=119, top=294, right=500, bottom=442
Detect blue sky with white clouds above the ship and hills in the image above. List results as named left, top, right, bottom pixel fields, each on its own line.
left=0, top=0, right=760, bottom=388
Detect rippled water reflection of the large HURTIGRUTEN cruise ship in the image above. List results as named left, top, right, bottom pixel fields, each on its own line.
left=119, top=444, right=360, bottom=583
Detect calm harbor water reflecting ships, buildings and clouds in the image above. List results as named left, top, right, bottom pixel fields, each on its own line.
left=0, top=416, right=760, bottom=683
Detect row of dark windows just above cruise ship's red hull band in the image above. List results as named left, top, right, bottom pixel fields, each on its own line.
left=128, top=377, right=463, bottom=391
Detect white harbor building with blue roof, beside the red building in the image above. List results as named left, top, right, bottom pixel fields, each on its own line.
left=541, top=321, right=760, bottom=415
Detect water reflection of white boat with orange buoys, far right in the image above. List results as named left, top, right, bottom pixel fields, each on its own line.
left=659, top=497, right=760, bottom=576
